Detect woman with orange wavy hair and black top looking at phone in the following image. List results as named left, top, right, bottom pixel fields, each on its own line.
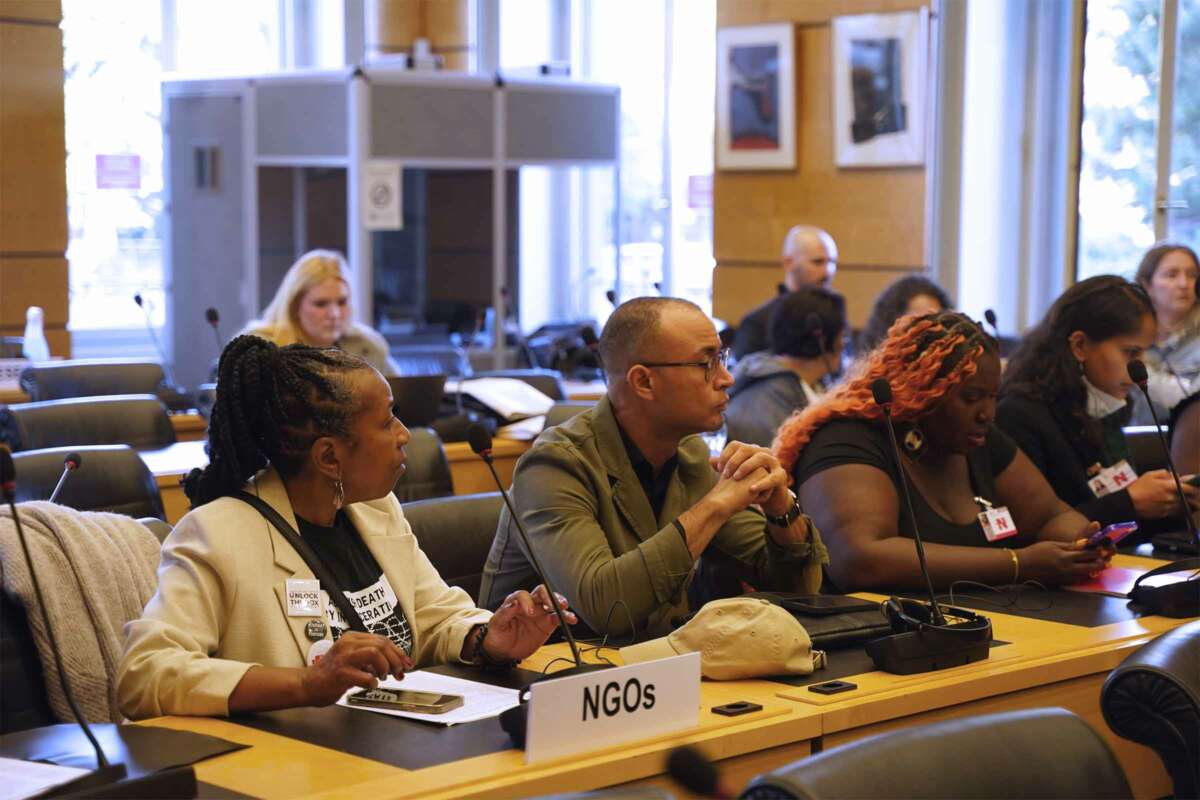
left=775, top=312, right=1109, bottom=591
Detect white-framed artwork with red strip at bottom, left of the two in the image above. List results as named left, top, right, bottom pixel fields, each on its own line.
left=716, top=23, right=796, bottom=169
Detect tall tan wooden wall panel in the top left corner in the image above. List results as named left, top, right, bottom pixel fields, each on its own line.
left=0, top=22, right=67, bottom=254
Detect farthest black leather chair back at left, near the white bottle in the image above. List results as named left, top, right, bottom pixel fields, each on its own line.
left=20, top=360, right=166, bottom=402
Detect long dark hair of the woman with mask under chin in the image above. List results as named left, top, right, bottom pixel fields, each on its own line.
left=1000, top=275, right=1154, bottom=455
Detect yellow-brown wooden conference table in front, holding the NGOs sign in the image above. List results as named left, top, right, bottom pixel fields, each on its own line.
left=143, top=555, right=1187, bottom=798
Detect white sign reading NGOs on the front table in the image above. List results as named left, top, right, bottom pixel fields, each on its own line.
left=526, top=652, right=700, bottom=764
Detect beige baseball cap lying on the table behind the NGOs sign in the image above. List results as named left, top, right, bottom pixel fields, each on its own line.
left=620, top=597, right=824, bottom=680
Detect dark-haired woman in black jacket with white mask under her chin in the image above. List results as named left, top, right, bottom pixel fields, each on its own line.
left=996, top=275, right=1200, bottom=525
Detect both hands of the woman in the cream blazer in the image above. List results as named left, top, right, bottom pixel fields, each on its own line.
left=300, top=585, right=576, bottom=705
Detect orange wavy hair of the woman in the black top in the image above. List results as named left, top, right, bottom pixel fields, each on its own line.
left=772, top=311, right=997, bottom=473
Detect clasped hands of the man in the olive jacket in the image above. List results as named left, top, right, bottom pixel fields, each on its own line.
left=709, top=441, right=808, bottom=545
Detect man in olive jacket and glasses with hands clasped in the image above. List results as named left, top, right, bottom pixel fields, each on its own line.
left=480, top=297, right=828, bottom=636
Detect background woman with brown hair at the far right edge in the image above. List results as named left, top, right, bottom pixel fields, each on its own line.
left=1134, top=242, right=1200, bottom=425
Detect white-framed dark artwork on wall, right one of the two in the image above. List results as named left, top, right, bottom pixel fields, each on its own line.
left=830, top=7, right=929, bottom=167
